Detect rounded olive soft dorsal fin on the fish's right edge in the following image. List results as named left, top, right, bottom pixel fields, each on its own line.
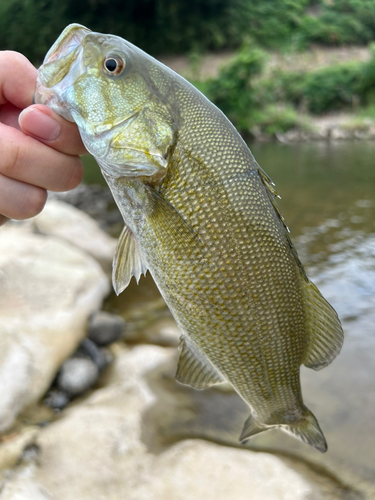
left=302, top=280, right=344, bottom=370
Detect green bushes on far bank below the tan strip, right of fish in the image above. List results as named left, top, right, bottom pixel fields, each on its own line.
left=194, top=41, right=375, bottom=135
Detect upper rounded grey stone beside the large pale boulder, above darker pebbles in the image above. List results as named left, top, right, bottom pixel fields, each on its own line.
left=87, top=311, right=125, bottom=345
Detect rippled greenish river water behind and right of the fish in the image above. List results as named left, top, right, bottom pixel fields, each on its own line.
left=84, top=142, right=375, bottom=491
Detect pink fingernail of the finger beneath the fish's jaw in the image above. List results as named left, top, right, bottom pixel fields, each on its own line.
left=18, top=108, right=61, bottom=141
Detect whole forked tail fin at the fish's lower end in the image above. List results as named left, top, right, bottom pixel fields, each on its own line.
left=240, top=406, right=327, bottom=453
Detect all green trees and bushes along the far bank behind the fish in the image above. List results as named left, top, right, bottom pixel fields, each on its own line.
left=0, top=0, right=375, bottom=135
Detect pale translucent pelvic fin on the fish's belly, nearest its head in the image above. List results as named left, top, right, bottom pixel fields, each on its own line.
left=112, top=226, right=147, bottom=295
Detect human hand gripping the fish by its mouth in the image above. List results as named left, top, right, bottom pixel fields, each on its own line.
left=0, top=51, right=87, bottom=226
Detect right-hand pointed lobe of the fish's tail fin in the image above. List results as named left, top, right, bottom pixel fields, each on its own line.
left=281, top=406, right=327, bottom=453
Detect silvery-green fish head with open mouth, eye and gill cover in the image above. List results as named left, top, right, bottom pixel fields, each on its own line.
left=34, top=24, right=177, bottom=179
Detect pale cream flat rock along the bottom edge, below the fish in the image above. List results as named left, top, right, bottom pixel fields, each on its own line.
left=0, top=346, right=350, bottom=500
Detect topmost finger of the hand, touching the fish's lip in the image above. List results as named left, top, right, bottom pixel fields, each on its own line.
left=0, top=50, right=37, bottom=109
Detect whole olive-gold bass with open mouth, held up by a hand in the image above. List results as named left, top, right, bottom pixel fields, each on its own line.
left=35, top=24, right=344, bottom=452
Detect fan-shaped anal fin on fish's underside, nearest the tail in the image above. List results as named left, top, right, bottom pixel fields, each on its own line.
left=176, top=336, right=225, bottom=389
